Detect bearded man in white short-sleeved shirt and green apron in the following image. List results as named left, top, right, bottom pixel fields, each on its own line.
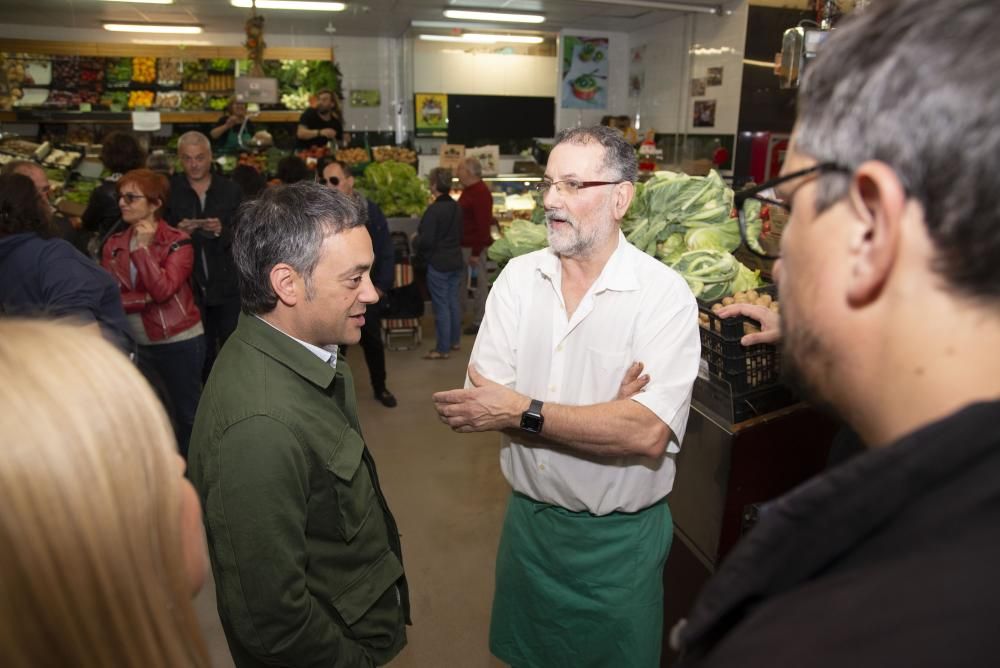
left=434, top=127, right=700, bottom=666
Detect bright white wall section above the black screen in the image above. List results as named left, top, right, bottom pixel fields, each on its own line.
left=413, top=40, right=558, bottom=97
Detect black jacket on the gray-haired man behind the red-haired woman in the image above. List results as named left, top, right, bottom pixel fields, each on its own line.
left=164, top=174, right=243, bottom=306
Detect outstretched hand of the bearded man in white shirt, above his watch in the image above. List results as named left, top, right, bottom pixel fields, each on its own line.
left=434, top=364, right=531, bottom=434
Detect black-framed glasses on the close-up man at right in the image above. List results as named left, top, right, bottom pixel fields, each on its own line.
left=733, top=162, right=852, bottom=260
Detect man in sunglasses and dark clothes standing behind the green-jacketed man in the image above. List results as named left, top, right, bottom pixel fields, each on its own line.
left=317, top=160, right=397, bottom=408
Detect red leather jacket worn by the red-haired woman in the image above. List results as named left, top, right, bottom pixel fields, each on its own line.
left=101, top=220, right=201, bottom=341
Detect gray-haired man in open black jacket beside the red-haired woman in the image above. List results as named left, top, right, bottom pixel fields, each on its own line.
left=166, top=132, right=243, bottom=380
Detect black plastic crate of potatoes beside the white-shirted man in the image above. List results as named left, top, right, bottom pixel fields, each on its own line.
left=698, top=285, right=781, bottom=395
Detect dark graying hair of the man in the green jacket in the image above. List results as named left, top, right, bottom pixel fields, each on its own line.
left=233, top=181, right=364, bottom=315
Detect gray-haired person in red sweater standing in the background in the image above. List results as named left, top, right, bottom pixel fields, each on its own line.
left=455, top=158, right=493, bottom=334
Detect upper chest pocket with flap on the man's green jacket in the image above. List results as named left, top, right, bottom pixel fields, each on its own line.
left=326, top=427, right=378, bottom=543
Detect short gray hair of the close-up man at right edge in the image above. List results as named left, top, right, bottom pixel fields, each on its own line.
left=795, top=0, right=1000, bottom=300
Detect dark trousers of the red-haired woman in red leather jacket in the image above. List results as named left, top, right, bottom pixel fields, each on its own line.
left=139, top=335, right=205, bottom=459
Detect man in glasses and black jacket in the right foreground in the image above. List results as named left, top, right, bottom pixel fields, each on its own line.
left=671, top=0, right=1000, bottom=668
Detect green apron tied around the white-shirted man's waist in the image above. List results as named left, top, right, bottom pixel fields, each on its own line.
left=490, top=492, right=673, bottom=668
